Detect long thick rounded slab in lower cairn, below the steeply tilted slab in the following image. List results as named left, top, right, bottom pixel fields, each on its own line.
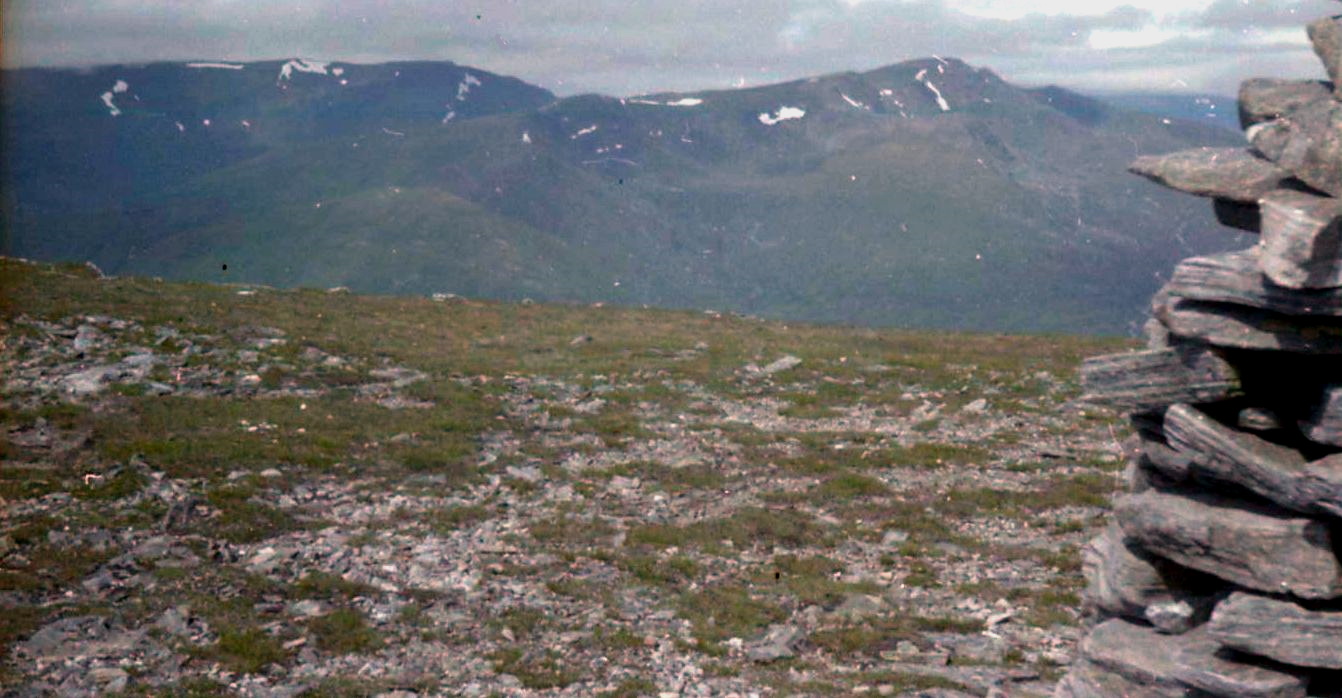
left=1115, top=490, right=1342, bottom=599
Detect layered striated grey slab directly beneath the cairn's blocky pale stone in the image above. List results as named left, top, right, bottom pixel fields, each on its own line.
left=1164, top=247, right=1342, bottom=318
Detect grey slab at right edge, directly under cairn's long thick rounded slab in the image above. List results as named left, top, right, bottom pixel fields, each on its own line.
left=1206, top=592, right=1342, bottom=668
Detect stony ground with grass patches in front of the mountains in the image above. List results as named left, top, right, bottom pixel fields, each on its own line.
left=0, top=260, right=1126, bottom=697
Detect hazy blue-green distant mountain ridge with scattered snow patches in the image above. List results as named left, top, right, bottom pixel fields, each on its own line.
left=3, top=58, right=1239, bottom=332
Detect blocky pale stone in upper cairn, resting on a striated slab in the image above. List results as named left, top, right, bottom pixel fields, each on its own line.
left=1259, top=187, right=1342, bottom=288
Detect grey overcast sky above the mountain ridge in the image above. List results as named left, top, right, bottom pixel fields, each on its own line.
left=3, top=0, right=1342, bottom=95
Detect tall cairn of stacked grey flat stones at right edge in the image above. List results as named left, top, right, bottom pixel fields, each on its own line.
left=1056, top=10, right=1342, bottom=698
